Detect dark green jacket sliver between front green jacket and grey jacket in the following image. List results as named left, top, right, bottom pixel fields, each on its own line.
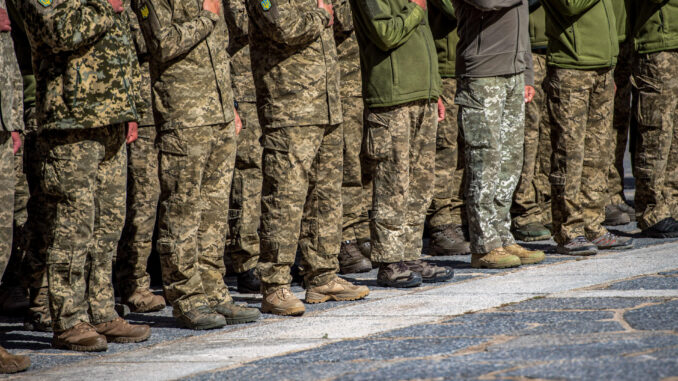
left=428, top=0, right=459, bottom=78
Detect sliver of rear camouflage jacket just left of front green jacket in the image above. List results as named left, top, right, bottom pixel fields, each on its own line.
left=332, top=0, right=363, bottom=97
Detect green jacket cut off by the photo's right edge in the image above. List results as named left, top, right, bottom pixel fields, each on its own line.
left=631, top=0, right=678, bottom=54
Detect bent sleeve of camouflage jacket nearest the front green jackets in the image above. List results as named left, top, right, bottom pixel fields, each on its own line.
left=247, top=0, right=330, bottom=46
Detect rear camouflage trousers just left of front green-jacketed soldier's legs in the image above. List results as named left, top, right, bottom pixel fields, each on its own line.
left=341, top=97, right=372, bottom=241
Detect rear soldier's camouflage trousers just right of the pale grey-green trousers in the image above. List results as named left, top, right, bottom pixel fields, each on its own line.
left=511, top=53, right=551, bottom=228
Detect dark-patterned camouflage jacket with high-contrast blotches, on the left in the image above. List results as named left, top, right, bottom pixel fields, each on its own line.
left=21, top=0, right=145, bottom=129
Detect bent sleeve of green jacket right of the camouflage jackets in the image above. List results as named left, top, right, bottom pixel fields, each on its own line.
left=354, top=0, right=426, bottom=51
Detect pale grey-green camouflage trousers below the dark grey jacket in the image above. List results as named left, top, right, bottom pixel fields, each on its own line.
left=455, top=74, right=525, bottom=254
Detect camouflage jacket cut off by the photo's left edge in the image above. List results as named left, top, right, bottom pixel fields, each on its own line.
left=0, top=0, right=24, bottom=132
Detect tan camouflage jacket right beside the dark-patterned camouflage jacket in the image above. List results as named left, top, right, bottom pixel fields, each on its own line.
left=132, top=0, right=234, bottom=130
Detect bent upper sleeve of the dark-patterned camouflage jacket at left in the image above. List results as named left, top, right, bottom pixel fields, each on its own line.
left=23, top=0, right=115, bottom=53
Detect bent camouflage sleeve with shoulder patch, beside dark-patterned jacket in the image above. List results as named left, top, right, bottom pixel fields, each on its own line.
left=132, top=0, right=219, bottom=62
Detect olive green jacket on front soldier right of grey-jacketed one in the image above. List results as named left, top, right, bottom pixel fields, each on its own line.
left=542, top=0, right=619, bottom=70
